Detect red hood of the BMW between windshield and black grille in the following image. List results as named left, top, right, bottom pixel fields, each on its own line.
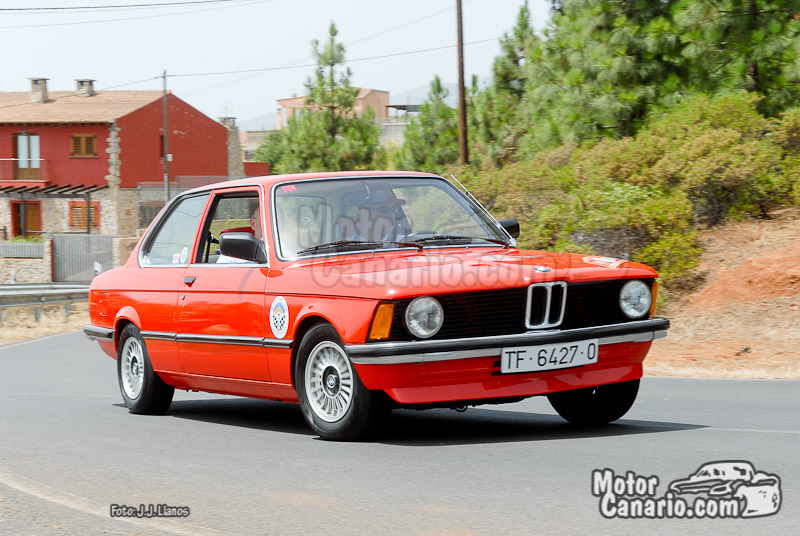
left=270, top=248, right=658, bottom=299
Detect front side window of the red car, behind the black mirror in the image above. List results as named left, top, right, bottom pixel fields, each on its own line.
left=194, top=192, right=261, bottom=264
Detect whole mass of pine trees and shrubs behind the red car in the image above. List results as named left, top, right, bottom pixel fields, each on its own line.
left=256, top=0, right=800, bottom=295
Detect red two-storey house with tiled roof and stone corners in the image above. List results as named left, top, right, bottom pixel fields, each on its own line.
left=0, top=78, right=229, bottom=240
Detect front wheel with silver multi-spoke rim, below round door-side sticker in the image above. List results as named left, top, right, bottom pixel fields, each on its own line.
left=295, top=323, right=389, bottom=441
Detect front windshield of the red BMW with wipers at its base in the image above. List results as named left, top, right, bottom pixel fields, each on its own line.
left=273, top=177, right=508, bottom=258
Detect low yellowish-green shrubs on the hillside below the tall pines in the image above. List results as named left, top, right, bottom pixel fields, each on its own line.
left=453, top=91, right=800, bottom=292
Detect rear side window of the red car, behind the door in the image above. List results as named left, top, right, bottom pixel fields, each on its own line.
left=142, top=194, right=208, bottom=265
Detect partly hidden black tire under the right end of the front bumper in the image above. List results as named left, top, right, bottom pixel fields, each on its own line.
left=547, top=380, right=639, bottom=425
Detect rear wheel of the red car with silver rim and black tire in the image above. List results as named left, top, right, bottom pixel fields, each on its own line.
left=117, top=324, right=175, bottom=415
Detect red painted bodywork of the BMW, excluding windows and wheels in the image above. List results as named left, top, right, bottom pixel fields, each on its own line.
left=85, top=172, right=669, bottom=440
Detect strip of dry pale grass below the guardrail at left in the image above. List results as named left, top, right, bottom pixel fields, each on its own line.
left=0, top=303, right=89, bottom=346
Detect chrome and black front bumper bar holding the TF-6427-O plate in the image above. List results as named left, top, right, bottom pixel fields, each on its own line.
left=345, top=318, right=669, bottom=365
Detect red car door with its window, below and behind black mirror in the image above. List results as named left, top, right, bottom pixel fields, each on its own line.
left=177, top=187, right=270, bottom=396
